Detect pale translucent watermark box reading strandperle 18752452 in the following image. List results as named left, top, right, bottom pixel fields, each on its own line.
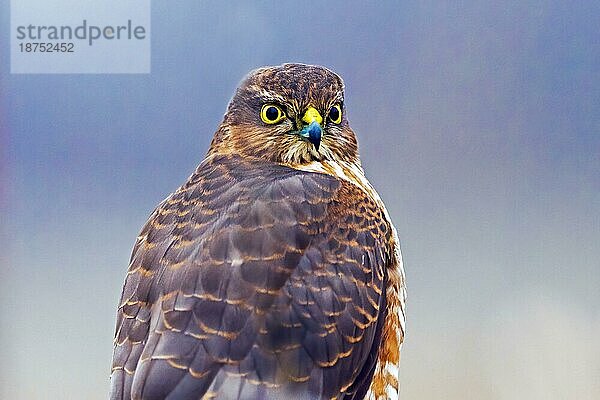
left=10, top=0, right=151, bottom=74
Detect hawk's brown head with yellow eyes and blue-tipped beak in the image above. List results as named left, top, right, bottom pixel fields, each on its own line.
left=209, top=64, right=359, bottom=165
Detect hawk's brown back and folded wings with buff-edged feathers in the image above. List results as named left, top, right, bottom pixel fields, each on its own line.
left=111, top=156, right=391, bottom=399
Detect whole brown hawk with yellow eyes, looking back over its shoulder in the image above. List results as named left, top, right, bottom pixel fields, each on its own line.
left=110, top=63, right=406, bottom=400
